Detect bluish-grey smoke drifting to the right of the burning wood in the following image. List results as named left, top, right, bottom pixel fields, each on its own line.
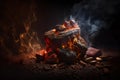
left=71, top=0, right=120, bottom=49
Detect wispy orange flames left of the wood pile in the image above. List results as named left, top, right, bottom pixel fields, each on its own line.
left=19, top=22, right=41, bottom=53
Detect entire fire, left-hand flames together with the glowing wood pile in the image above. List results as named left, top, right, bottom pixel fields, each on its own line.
left=10, top=20, right=86, bottom=63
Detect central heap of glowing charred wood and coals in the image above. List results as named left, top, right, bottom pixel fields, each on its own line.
left=45, top=20, right=87, bottom=62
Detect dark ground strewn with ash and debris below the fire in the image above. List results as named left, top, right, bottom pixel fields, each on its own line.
left=0, top=56, right=120, bottom=80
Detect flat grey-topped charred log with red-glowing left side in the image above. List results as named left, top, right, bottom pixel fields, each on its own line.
left=45, top=27, right=80, bottom=50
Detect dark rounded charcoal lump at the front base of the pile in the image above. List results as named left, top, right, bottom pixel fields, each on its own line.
left=58, top=49, right=76, bottom=64
